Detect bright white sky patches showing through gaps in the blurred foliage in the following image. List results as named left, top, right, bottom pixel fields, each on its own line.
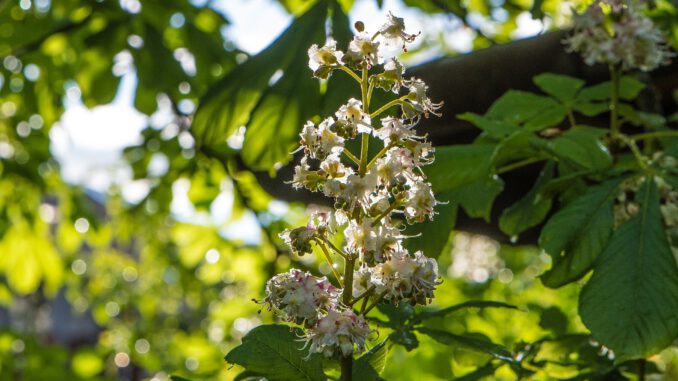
left=51, top=0, right=543, bottom=243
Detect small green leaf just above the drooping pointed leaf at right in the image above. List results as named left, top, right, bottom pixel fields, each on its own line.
left=547, top=126, right=612, bottom=170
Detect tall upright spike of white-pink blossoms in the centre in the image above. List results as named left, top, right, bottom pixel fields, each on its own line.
left=265, top=14, right=441, bottom=357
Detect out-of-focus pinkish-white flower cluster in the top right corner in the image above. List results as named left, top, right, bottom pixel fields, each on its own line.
left=565, top=0, right=674, bottom=71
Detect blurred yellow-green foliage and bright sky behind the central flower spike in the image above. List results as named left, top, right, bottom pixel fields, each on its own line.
left=0, top=0, right=678, bottom=381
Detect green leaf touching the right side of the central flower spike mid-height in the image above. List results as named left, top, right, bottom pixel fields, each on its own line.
left=424, top=144, right=495, bottom=193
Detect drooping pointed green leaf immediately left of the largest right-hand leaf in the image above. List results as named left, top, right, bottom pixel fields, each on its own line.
left=539, top=179, right=622, bottom=287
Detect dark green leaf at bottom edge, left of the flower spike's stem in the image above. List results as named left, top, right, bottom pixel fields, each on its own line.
left=226, top=324, right=326, bottom=381
